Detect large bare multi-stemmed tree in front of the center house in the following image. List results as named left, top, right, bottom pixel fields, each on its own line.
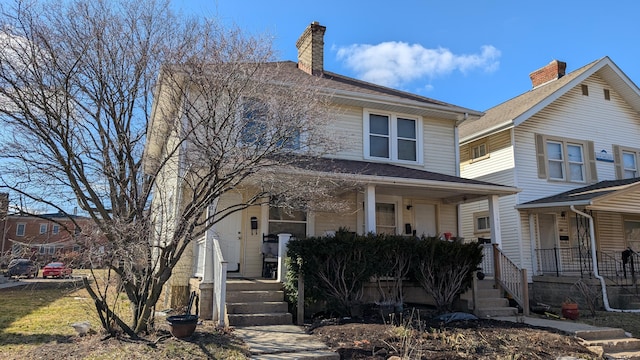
left=0, top=0, right=334, bottom=337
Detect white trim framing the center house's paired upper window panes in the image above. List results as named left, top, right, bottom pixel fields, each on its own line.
left=362, top=109, right=424, bottom=165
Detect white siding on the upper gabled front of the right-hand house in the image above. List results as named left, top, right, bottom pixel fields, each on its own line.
left=515, top=75, right=640, bottom=203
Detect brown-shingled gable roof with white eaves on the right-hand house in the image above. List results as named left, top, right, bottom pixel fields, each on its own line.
left=459, top=56, right=640, bottom=144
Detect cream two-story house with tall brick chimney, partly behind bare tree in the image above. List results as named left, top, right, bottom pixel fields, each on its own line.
left=146, top=23, right=517, bottom=324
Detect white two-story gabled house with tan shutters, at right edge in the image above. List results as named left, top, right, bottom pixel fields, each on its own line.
left=460, top=57, right=640, bottom=307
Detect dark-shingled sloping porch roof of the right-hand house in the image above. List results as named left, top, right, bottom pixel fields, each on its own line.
left=516, top=178, right=640, bottom=212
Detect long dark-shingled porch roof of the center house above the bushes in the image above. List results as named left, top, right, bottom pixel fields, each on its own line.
left=278, top=157, right=520, bottom=202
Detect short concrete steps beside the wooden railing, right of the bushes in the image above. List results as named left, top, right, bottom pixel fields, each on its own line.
left=462, top=279, right=518, bottom=318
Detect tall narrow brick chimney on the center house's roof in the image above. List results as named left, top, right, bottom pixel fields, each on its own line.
left=296, top=21, right=327, bottom=75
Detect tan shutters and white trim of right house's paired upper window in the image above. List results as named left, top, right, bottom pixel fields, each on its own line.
left=535, top=134, right=598, bottom=184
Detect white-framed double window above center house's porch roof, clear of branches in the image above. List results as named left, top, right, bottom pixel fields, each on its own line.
left=364, top=110, right=422, bottom=163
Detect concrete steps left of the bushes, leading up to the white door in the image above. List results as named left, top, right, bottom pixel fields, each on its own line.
left=227, top=279, right=293, bottom=326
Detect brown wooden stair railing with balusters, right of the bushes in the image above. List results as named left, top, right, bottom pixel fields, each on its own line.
left=492, top=244, right=529, bottom=316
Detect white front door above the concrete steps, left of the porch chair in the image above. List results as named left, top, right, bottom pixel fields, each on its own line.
left=213, top=193, right=242, bottom=271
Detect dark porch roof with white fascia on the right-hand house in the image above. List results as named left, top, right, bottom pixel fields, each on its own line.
left=516, top=178, right=640, bottom=213
